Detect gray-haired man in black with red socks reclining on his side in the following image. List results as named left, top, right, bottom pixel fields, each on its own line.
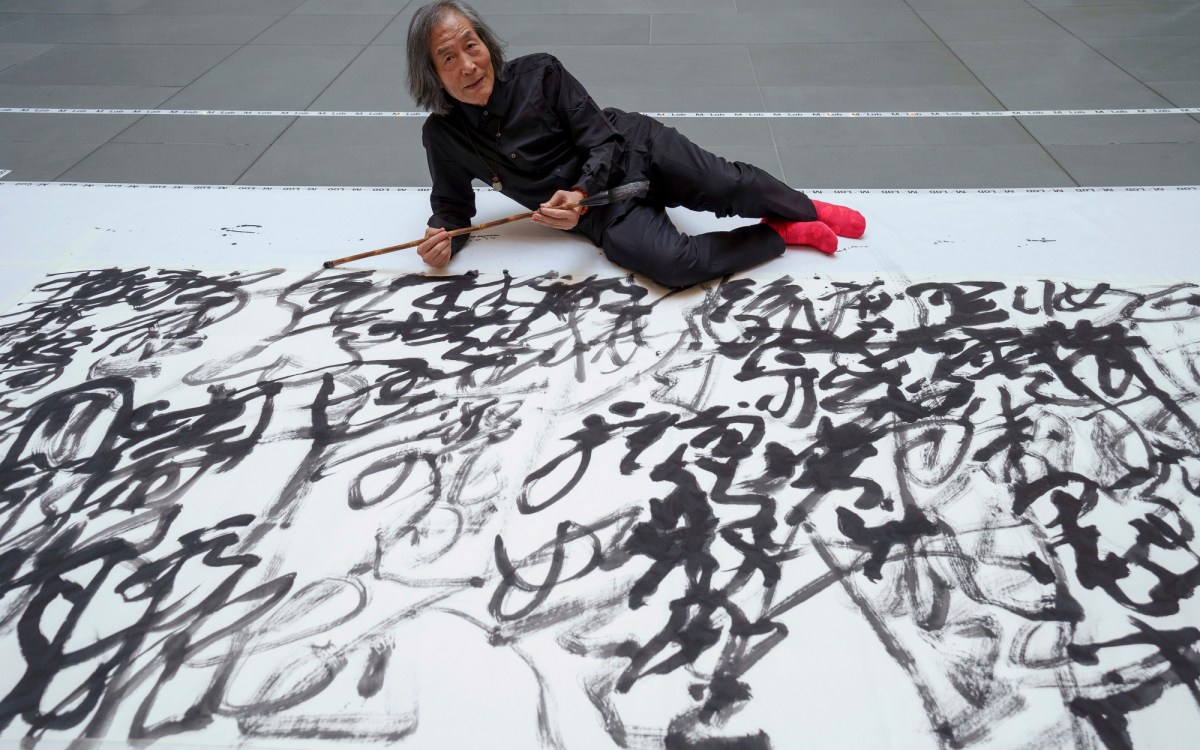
left=408, top=0, right=866, bottom=287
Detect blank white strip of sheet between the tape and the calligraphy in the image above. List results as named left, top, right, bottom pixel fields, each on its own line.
left=0, top=182, right=1200, bottom=300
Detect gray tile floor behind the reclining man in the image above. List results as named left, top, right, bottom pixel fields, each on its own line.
left=0, top=0, right=1200, bottom=188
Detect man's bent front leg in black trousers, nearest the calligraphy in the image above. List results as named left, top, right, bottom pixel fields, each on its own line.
left=600, top=204, right=785, bottom=287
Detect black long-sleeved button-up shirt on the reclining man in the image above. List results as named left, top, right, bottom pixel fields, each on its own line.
left=422, top=53, right=626, bottom=252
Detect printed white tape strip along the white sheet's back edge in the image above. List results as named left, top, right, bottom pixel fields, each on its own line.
left=0, top=180, right=1200, bottom=196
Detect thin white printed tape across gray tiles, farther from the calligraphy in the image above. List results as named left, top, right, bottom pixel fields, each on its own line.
left=7, top=107, right=1200, bottom=120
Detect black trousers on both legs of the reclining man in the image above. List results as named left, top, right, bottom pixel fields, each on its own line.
left=599, top=115, right=817, bottom=287
